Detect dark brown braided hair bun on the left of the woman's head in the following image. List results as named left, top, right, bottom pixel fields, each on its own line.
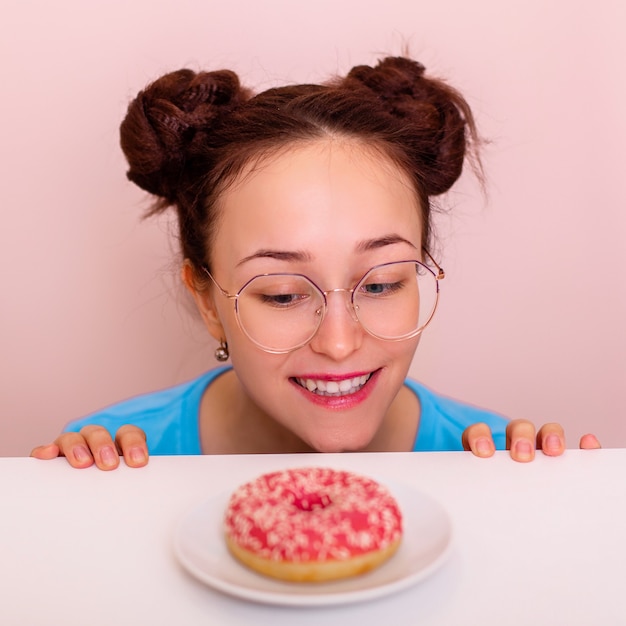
left=120, top=69, right=248, bottom=204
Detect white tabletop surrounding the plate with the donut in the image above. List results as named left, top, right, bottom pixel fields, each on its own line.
left=0, top=450, right=626, bottom=626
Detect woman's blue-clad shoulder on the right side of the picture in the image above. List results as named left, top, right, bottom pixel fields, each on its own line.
left=405, top=379, right=509, bottom=450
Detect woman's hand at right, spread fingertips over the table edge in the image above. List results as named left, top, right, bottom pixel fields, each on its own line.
left=463, top=420, right=601, bottom=463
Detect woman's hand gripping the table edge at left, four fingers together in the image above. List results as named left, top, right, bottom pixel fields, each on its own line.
left=30, top=424, right=148, bottom=470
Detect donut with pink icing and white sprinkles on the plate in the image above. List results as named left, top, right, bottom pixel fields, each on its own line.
left=224, top=467, right=402, bottom=582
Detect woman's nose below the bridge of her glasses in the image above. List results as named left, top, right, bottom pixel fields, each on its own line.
left=310, top=289, right=364, bottom=361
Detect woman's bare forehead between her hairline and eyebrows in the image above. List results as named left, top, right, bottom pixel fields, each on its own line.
left=214, top=141, right=421, bottom=264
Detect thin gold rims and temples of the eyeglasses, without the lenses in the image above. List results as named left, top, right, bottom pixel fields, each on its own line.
left=202, top=248, right=446, bottom=354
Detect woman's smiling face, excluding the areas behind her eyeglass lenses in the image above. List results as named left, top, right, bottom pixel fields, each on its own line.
left=202, top=140, right=422, bottom=452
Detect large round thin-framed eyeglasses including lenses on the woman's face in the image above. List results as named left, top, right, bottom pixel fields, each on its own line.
left=204, top=252, right=445, bottom=354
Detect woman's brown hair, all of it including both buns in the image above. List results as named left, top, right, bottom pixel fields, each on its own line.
left=120, top=57, right=479, bottom=269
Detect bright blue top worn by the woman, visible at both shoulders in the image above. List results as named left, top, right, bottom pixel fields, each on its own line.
left=65, top=366, right=507, bottom=455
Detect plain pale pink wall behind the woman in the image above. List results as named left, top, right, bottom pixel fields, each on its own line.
left=0, top=0, right=626, bottom=455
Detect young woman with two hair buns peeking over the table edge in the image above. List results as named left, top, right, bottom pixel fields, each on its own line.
left=32, top=57, right=598, bottom=469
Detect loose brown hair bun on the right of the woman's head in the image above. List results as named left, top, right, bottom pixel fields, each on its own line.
left=345, top=57, right=479, bottom=195
